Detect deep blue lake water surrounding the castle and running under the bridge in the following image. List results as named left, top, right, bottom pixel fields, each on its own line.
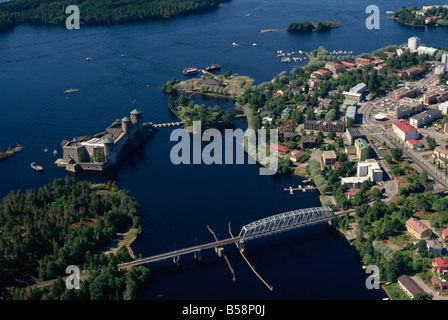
left=0, top=0, right=448, bottom=300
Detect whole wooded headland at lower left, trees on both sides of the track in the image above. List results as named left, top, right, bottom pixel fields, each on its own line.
left=0, top=176, right=149, bottom=299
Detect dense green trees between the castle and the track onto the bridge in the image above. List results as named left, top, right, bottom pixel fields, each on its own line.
left=0, top=176, right=141, bottom=294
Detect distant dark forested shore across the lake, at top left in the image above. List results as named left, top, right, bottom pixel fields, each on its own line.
left=0, top=0, right=229, bottom=32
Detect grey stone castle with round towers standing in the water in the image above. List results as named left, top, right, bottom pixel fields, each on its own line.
left=55, top=109, right=156, bottom=172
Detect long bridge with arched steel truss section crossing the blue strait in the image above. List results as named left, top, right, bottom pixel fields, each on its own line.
left=118, top=207, right=345, bottom=269
